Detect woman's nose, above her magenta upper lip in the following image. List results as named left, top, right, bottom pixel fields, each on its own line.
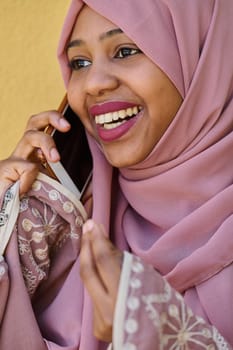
left=85, top=61, right=119, bottom=96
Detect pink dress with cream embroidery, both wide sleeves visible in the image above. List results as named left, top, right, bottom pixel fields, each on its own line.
left=0, top=174, right=231, bottom=350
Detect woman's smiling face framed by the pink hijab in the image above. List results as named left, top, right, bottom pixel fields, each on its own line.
left=67, top=6, right=182, bottom=167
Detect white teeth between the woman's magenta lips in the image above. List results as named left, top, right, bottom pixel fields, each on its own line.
left=95, top=106, right=142, bottom=129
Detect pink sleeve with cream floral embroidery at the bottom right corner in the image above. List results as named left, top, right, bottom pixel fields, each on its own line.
left=112, top=253, right=232, bottom=350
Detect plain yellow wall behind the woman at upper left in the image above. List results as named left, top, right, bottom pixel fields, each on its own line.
left=0, top=0, right=70, bottom=159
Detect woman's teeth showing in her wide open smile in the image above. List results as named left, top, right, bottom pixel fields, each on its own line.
left=95, top=106, right=142, bottom=130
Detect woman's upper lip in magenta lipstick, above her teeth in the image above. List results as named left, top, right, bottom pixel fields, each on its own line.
left=89, top=101, right=138, bottom=117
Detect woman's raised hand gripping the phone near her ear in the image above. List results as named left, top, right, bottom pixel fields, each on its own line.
left=0, top=111, right=70, bottom=194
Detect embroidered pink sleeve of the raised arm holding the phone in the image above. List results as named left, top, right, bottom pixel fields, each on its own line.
left=0, top=174, right=86, bottom=350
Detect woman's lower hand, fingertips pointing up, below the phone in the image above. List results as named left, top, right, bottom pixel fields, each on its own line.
left=80, top=220, right=123, bottom=342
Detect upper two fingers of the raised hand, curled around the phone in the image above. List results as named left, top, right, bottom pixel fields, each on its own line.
left=12, top=111, right=70, bottom=162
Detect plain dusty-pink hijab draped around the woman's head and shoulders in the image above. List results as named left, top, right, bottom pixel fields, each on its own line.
left=58, top=0, right=233, bottom=344
